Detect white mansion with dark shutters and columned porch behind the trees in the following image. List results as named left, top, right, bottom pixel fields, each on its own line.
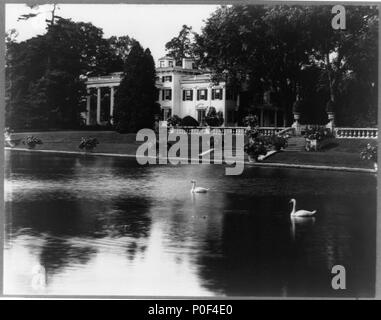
left=86, top=56, right=285, bottom=126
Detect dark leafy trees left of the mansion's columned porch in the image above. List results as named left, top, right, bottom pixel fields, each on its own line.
left=6, top=17, right=133, bottom=129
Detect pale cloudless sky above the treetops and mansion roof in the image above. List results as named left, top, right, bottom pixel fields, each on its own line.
left=5, top=4, right=218, bottom=63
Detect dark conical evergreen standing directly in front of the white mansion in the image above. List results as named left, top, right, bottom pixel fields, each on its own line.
left=114, top=42, right=159, bottom=132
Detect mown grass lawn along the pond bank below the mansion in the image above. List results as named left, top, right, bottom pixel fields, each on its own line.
left=7, top=131, right=377, bottom=169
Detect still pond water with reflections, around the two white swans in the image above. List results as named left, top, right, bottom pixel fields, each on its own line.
left=4, top=151, right=376, bottom=296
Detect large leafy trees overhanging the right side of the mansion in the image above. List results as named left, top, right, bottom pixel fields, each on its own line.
left=192, top=5, right=378, bottom=125
